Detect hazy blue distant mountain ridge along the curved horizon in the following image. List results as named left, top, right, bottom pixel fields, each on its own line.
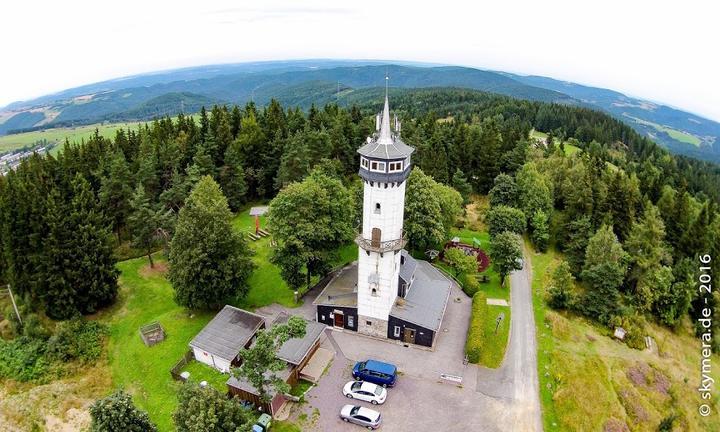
left=0, top=60, right=720, bottom=162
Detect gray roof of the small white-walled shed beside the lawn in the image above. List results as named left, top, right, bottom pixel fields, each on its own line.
left=190, top=305, right=265, bottom=361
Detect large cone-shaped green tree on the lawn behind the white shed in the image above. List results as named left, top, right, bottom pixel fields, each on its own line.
left=169, top=176, right=253, bottom=309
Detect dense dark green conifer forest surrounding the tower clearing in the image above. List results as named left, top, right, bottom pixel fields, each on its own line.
left=0, top=89, right=720, bottom=352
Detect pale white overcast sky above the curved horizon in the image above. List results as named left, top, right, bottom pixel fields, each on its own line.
left=0, top=0, right=720, bottom=121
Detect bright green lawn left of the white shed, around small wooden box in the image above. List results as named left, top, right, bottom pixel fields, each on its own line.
left=101, top=255, right=213, bottom=431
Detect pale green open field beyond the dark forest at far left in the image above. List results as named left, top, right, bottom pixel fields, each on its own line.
left=0, top=122, right=145, bottom=154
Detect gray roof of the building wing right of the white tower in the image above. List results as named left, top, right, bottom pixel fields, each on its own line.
left=390, top=260, right=451, bottom=331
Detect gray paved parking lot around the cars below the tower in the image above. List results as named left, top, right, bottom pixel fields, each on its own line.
left=286, top=289, right=512, bottom=432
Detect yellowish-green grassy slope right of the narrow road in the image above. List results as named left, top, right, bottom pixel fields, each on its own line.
left=530, top=240, right=720, bottom=431
